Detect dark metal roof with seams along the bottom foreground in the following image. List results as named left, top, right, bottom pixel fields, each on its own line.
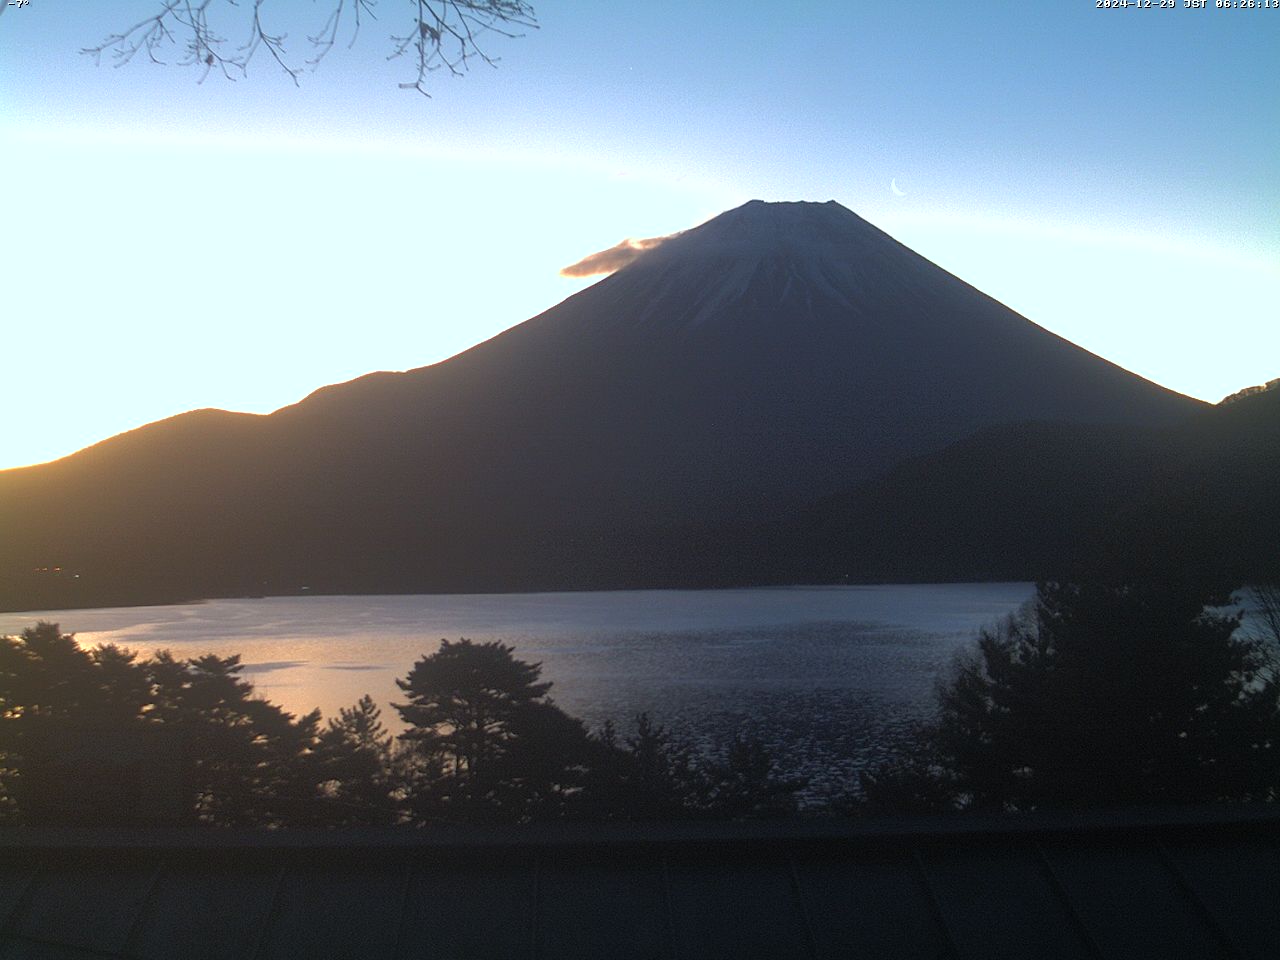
left=0, top=809, right=1280, bottom=960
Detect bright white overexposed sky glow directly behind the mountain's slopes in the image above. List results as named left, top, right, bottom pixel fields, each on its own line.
left=0, top=120, right=1280, bottom=466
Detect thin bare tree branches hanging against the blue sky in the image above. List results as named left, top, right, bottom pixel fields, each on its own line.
left=81, top=0, right=538, bottom=96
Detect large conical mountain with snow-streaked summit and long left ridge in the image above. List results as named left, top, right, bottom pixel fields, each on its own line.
left=0, top=201, right=1203, bottom=609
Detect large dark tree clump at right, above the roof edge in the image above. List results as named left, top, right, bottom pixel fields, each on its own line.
left=931, top=581, right=1280, bottom=809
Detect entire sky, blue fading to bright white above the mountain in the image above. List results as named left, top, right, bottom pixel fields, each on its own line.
left=0, top=0, right=1280, bottom=467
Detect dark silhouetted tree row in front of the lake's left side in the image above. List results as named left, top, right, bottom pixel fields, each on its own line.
left=0, top=632, right=804, bottom=827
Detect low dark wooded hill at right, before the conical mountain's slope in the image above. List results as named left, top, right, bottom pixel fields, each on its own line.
left=793, top=390, right=1280, bottom=589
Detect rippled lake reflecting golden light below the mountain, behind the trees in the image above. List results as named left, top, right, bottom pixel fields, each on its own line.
left=0, top=584, right=1034, bottom=799
